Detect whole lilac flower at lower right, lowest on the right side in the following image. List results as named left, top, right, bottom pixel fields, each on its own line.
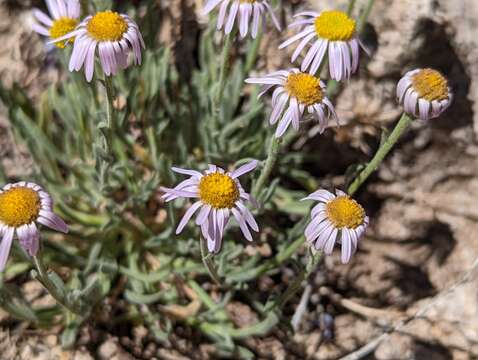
left=303, top=189, right=369, bottom=264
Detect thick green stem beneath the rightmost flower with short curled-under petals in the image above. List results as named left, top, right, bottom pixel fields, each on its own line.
left=348, top=113, right=413, bottom=195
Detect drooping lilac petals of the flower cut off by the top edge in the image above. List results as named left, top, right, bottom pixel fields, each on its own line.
left=203, top=0, right=281, bottom=39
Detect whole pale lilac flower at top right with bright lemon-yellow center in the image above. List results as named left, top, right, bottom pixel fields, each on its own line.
left=279, top=11, right=365, bottom=81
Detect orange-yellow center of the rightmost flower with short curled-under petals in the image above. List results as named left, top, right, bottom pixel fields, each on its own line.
left=412, top=69, right=448, bottom=101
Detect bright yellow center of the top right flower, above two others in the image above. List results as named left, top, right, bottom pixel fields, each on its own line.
left=315, top=11, right=355, bottom=41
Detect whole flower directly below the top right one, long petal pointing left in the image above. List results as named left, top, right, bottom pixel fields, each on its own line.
left=246, top=69, right=337, bottom=137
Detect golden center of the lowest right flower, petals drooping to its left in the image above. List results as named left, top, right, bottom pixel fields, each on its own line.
left=325, top=195, right=365, bottom=229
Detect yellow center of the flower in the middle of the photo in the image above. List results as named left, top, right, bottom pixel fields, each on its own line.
left=199, top=172, right=239, bottom=209
